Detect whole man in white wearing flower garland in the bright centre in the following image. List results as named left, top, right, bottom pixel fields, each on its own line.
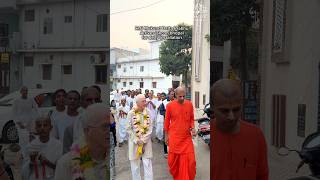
left=127, top=94, right=153, bottom=180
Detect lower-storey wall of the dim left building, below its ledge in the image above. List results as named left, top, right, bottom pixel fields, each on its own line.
left=21, top=52, right=107, bottom=91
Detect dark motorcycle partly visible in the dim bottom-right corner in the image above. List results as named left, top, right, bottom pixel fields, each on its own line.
left=278, top=132, right=320, bottom=180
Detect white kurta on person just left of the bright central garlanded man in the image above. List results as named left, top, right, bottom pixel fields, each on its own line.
left=117, top=105, right=130, bottom=143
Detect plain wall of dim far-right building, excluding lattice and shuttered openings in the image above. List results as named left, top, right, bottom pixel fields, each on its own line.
left=261, top=0, right=320, bottom=148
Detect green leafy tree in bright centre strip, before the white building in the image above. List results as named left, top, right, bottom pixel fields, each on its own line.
left=160, top=24, right=192, bottom=90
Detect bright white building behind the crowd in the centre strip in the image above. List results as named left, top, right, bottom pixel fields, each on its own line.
left=115, top=41, right=173, bottom=93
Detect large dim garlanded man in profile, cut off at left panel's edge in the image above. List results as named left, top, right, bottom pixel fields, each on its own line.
left=55, top=103, right=110, bottom=180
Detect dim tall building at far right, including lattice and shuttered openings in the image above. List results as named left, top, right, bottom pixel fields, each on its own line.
left=260, top=0, right=320, bottom=149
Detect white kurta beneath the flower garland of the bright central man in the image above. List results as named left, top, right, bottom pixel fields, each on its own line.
left=127, top=109, right=153, bottom=161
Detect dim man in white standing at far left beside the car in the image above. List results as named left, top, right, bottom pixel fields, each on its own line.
left=12, top=86, right=39, bottom=160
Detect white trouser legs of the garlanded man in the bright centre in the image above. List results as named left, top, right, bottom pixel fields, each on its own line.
left=130, top=158, right=153, bottom=180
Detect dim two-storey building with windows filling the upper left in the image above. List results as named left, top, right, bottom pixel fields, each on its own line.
left=13, top=0, right=109, bottom=97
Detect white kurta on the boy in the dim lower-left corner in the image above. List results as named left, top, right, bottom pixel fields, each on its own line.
left=22, top=137, right=62, bottom=180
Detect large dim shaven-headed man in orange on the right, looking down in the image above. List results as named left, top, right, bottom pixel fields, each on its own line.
left=210, top=79, right=268, bottom=180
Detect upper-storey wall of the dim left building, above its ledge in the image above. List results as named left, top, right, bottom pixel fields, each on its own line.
left=20, top=0, right=107, bottom=49
